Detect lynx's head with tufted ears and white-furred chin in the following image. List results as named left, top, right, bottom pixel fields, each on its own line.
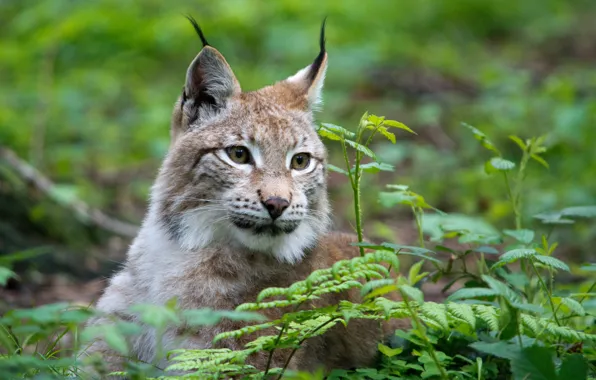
left=152, top=18, right=329, bottom=263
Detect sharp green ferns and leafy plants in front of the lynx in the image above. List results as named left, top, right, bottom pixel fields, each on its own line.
left=0, top=110, right=596, bottom=380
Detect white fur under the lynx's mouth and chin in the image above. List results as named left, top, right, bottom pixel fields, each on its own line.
left=232, top=222, right=318, bottom=264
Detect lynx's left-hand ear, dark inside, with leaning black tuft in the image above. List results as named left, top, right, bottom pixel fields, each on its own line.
left=183, top=17, right=241, bottom=110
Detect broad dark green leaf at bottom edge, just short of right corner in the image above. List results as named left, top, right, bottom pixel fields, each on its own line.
left=511, top=346, right=569, bottom=380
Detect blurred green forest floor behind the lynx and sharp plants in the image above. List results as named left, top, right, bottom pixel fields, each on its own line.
left=0, top=0, right=596, bottom=302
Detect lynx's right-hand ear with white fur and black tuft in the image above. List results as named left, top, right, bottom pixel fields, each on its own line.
left=285, top=18, right=327, bottom=109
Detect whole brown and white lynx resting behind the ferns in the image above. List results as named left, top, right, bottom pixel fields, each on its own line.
left=87, top=18, right=400, bottom=378
